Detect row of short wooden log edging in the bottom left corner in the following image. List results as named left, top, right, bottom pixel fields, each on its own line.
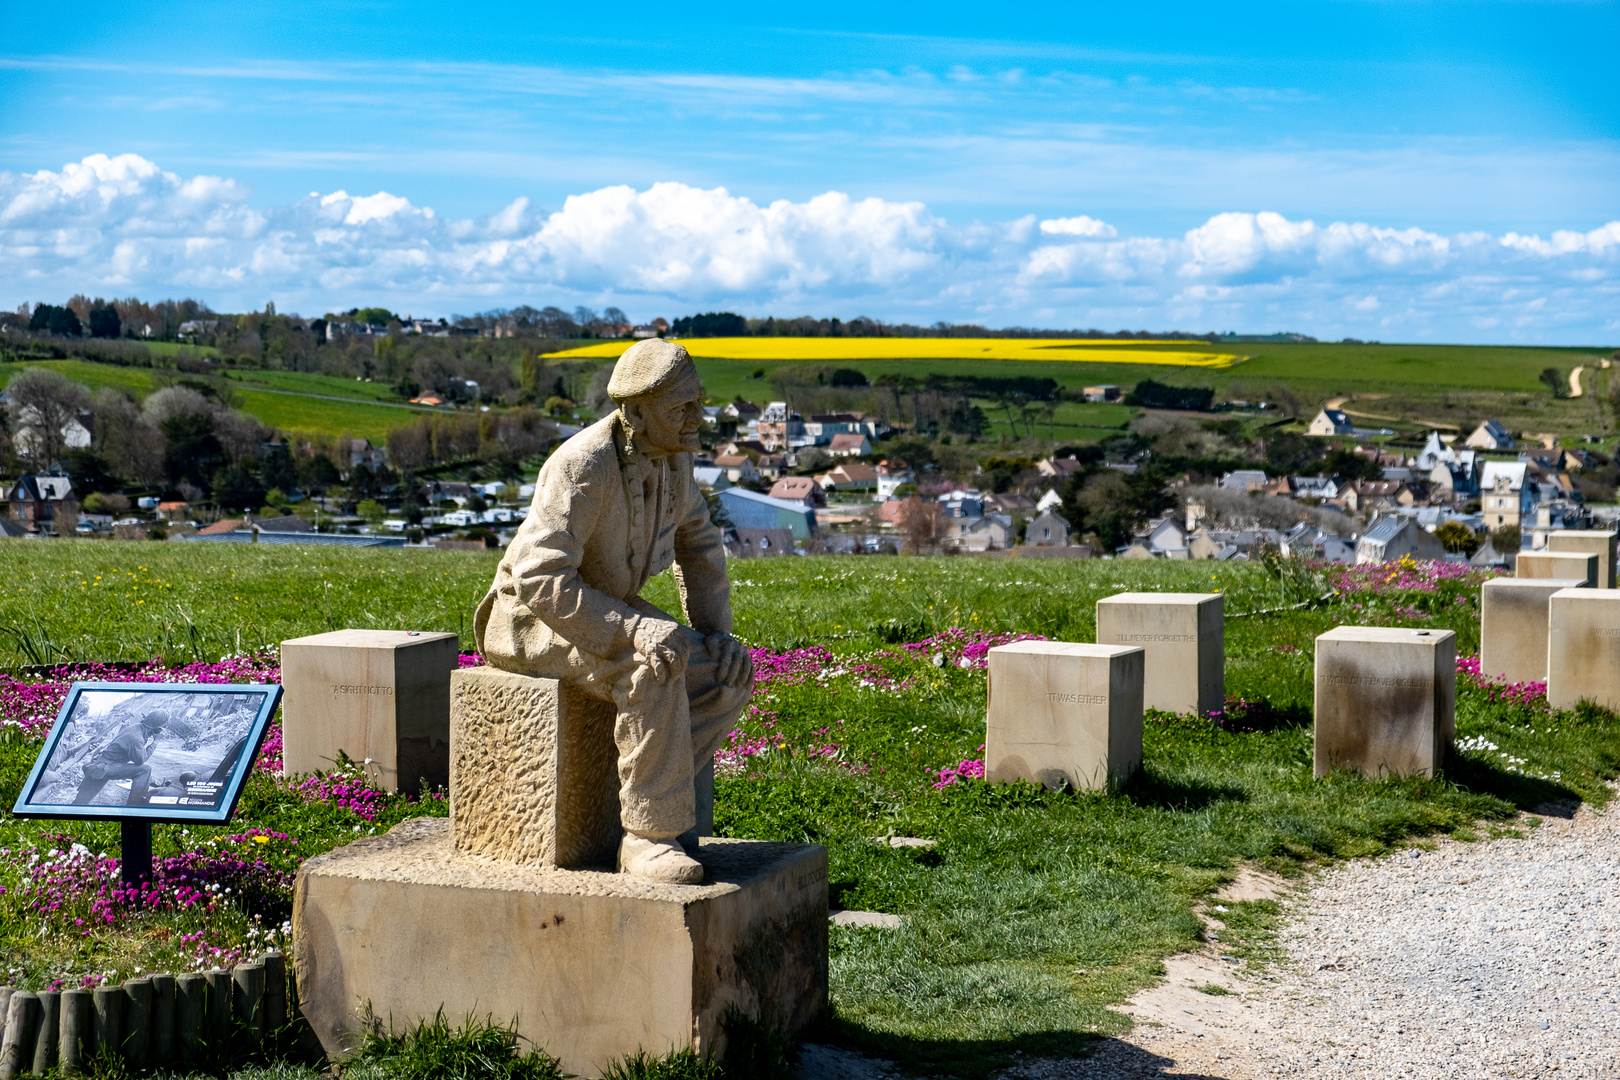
left=0, top=952, right=290, bottom=1080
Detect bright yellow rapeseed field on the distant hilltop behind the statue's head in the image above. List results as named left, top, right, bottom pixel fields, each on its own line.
left=551, top=337, right=1243, bottom=368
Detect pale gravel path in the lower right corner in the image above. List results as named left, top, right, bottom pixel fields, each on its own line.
left=1006, top=806, right=1620, bottom=1080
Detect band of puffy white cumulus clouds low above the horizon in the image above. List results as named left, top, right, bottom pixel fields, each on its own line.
left=0, top=154, right=1620, bottom=345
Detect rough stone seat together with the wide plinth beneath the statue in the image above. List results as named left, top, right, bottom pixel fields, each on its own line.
left=293, top=667, right=828, bottom=1075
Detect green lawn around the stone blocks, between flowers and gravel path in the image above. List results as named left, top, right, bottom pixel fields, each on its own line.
left=0, top=541, right=1620, bottom=1077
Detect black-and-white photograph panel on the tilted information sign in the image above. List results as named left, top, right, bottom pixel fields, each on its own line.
left=21, top=683, right=267, bottom=811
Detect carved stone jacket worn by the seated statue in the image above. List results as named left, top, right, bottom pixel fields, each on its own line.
left=473, top=411, right=731, bottom=683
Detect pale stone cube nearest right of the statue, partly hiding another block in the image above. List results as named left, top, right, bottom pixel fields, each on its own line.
left=985, top=641, right=1145, bottom=790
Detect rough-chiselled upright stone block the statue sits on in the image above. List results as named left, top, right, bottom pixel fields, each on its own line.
left=450, top=667, right=624, bottom=868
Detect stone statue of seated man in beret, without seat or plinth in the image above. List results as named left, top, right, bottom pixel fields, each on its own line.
left=475, top=338, right=753, bottom=884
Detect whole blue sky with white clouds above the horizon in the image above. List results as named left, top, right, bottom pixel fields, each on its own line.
left=0, top=0, right=1620, bottom=345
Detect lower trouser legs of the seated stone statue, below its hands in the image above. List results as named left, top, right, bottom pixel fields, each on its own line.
left=614, top=630, right=750, bottom=839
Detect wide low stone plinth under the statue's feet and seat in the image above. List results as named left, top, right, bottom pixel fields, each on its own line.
left=293, top=818, right=828, bottom=1077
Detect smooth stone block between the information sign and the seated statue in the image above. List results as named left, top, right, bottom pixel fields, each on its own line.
left=282, top=630, right=457, bottom=792
